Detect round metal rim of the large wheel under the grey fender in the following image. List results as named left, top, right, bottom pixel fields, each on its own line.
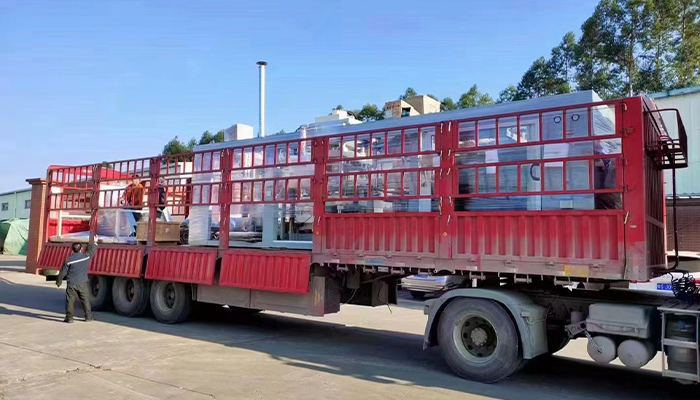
left=453, top=314, right=498, bottom=363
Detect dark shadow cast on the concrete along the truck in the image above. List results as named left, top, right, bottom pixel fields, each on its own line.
left=0, top=278, right=697, bottom=400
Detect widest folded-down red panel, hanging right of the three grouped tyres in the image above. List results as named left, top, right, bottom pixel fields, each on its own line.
left=219, top=250, right=311, bottom=293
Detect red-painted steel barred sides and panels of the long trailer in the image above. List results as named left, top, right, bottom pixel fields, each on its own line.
left=41, top=97, right=684, bottom=293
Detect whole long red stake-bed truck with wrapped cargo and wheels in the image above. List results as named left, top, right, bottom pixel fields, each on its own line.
left=32, top=92, right=700, bottom=382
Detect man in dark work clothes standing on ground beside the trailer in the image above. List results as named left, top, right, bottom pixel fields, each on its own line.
left=56, top=241, right=97, bottom=324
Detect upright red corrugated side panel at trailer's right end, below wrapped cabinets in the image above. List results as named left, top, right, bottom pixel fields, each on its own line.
left=454, top=211, right=624, bottom=276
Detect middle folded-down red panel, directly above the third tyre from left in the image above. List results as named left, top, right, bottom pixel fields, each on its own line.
left=146, top=247, right=217, bottom=285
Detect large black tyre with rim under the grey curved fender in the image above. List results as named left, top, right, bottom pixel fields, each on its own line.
left=438, top=298, right=523, bottom=383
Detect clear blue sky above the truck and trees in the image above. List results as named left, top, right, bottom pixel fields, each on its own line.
left=0, top=0, right=597, bottom=192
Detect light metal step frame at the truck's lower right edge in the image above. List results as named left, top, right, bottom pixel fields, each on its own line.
left=658, top=300, right=700, bottom=383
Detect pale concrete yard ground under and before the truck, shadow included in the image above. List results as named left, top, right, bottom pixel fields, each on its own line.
left=0, top=256, right=700, bottom=400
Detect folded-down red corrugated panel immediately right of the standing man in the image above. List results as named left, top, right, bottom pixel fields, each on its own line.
left=90, top=245, right=144, bottom=278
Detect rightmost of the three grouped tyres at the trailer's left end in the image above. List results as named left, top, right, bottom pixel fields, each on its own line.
left=151, top=281, right=192, bottom=324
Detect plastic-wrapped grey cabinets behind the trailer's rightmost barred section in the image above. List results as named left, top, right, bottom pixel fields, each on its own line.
left=455, top=106, right=622, bottom=211
